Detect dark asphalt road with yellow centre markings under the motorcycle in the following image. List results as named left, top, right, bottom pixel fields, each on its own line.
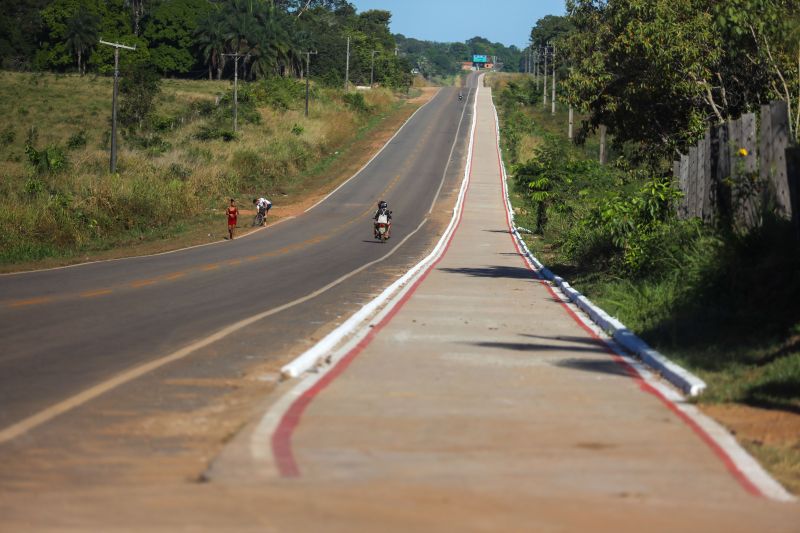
left=0, top=77, right=475, bottom=432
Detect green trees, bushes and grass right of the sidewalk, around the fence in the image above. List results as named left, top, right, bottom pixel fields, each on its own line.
left=490, top=0, right=800, bottom=492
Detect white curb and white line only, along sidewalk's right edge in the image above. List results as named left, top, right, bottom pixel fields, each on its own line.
left=492, top=85, right=797, bottom=502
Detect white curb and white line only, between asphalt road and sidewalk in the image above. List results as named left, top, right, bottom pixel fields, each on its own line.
left=250, top=78, right=481, bottom=476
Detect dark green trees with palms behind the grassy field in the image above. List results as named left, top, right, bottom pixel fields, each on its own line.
left=0, top=0, right=412, bottom=87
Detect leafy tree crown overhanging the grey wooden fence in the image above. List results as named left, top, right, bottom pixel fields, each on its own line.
left=531, top=0, right=800, bottom=160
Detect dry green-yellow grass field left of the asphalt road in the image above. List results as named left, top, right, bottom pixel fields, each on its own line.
left=0, top=72, right=408, bottom=268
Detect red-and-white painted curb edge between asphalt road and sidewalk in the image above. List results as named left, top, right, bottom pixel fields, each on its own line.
left=250, top=76, right=480, bottom=477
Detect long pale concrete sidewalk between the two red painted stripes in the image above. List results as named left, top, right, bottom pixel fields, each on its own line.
left=273, top=85, right=800, bottom=532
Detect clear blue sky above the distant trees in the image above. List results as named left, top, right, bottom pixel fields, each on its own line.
left=350, top=0, right=565, bottom=48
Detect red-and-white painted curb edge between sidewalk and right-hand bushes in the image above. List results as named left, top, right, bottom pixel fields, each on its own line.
left=492, top=89, right=796, bottom=502
